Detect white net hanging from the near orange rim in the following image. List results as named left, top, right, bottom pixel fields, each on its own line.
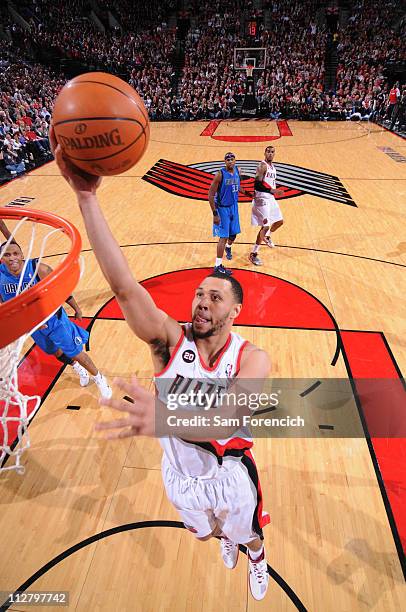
left=0, top=217, right=62, bottom=474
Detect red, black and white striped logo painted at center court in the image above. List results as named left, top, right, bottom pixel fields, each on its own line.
left=142, top=159, right=357, bottom=206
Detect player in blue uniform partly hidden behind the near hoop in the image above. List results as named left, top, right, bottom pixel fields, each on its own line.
left=0, top=241, right=112, bottom=398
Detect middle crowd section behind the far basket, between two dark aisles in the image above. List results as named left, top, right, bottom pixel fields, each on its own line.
left=180, top=0, right=325, bottom=119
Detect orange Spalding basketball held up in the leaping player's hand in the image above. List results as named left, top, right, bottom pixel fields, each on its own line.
left=52, top=72, right=149, bottom=176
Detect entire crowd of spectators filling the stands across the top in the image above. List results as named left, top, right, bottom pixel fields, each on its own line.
left=0, top=0, right=406, bottom=180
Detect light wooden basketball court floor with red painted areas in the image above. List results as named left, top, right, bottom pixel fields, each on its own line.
left=0, top=121, right=406, bottom=612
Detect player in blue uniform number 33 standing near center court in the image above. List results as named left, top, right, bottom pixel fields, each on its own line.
left=209, top=153, right=252, bottom=275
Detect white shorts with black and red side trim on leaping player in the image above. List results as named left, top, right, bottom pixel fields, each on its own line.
left=162, top=451, right=270, bottom=544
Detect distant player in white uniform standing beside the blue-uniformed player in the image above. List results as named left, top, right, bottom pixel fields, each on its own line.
left=249, top=146, right=283, bottom=266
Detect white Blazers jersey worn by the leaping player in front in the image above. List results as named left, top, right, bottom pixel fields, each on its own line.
left=155, top=323, right=252, bottom=478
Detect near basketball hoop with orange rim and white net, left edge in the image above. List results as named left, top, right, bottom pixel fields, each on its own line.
left=0, top=208, right=82, bottom=473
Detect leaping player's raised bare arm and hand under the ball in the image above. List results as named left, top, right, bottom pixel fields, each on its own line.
left=50, top=128, right=181, bottom=346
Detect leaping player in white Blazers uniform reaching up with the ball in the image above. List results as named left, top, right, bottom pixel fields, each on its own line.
left=50, top=129, right=270, bottom=600
